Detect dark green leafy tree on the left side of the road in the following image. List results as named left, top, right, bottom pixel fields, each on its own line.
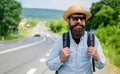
left=0, top=0, right=22, bottom=38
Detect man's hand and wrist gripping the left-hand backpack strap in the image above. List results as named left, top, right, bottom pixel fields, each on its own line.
left=60, top=47, right=71, bottom=62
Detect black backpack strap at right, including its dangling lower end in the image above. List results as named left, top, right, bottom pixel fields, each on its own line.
left=87, top=31, right=95, bottom=72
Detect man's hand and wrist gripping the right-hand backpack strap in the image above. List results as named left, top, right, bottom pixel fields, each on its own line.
left=88, top=46, right=99, bottom=61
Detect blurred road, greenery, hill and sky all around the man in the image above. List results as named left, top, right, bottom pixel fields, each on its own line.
left=0, top=0, right=120, bottom=74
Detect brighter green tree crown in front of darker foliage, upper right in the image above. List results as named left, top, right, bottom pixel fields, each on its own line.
left=94, top=6, right=115, bottom=27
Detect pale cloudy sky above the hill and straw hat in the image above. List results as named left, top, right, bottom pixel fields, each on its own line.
left=17, top=0, right=99, bottom=10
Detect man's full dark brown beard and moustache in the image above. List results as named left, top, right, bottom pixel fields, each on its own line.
left=70, top=23, right=85, bottom=39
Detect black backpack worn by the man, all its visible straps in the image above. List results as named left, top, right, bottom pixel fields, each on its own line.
left=55, top=31, right=95, bottom=74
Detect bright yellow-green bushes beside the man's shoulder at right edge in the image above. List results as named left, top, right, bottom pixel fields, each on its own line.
left=95, top=24, right=120, bottom=67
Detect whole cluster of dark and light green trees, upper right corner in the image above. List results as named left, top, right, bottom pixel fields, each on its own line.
left=87, top=0, right=120, bottom=30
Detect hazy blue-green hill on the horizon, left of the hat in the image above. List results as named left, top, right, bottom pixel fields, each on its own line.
left=22, top=8, right=63, bottom=20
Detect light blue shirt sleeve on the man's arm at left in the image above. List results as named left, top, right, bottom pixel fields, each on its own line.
left=46, top=37, right=63, bottom=70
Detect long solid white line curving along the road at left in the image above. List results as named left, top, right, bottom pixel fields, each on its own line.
left=0, top=37, right=46, bottom=54
